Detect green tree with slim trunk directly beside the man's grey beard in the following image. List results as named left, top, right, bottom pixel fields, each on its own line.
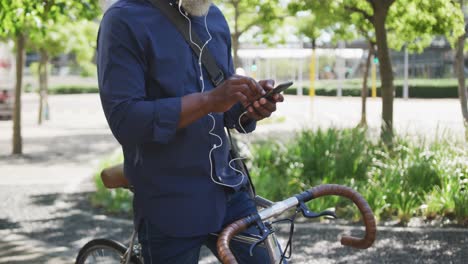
left=215, top=0, right=284, bottom=67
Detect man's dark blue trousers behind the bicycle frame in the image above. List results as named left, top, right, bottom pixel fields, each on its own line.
left=138, top=191, right=269, bottom=264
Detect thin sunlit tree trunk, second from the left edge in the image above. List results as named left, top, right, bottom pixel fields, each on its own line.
left=37, top=49, right=49, bottom=125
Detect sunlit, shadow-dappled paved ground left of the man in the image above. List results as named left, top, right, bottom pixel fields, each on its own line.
left=0, top=94, right=122, bottom=263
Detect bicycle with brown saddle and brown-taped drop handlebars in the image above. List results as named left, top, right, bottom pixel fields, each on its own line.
left=76, top=166, right=377, bottom=264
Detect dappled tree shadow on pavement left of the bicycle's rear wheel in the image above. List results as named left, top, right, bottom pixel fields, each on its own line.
left=0, top=193, right=133, bottom=264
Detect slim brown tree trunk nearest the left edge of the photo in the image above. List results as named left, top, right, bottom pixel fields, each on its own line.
left=13, top=34, right=26, bottom=155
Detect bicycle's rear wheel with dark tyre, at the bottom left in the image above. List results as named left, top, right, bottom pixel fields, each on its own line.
left=75, top=239, right=142, bottom=264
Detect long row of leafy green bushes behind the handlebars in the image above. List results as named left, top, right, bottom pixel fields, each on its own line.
left=251, top=129, right=468, bottom=224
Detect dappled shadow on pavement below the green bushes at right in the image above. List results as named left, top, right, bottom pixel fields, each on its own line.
left=279, top=224, right=468, bottom=263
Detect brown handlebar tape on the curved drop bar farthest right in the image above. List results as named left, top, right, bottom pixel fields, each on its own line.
left=309, top=184, right=377, bottom=249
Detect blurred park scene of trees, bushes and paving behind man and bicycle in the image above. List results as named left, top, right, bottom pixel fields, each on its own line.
left=0, top=0, right=468, bottom=263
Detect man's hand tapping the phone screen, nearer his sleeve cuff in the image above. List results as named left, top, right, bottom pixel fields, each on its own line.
left=207, top=75, right=265, bottom=113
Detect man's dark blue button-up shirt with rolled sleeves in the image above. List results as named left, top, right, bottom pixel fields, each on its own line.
left=97, top=0, right=256, bottom=235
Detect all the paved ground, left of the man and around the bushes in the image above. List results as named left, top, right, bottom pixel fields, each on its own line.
left=0, top=95, right=468, bottom=263
